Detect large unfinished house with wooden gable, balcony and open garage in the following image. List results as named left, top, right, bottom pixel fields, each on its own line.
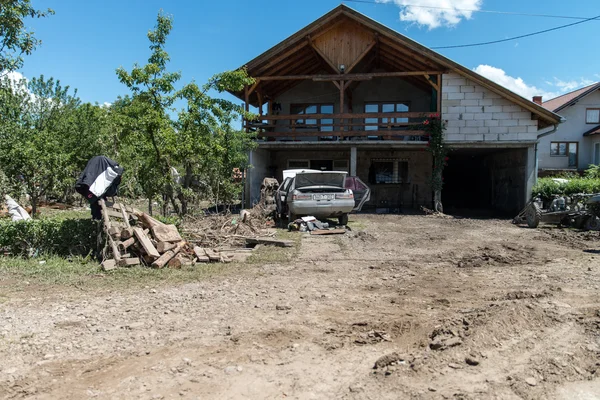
left=233, top=5, right=560, bottom=212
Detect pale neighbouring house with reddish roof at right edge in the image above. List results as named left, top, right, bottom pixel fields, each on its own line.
left=534, top=82, right=600, bottom=175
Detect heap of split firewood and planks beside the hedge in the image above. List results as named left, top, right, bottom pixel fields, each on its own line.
left=99, top=200, right=232, bottom=270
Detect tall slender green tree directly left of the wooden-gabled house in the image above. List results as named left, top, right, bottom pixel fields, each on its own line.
left=117, top=13, right=254, bottom=214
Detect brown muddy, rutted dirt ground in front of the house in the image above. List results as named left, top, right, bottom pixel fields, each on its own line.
left=0, top=215, right=600, bottom=399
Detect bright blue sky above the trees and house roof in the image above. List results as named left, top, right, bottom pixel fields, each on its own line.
left=20, top=0, right=600, bottom=103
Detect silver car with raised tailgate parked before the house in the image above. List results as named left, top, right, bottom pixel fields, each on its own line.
left=276, top=170, right=356, bottom=225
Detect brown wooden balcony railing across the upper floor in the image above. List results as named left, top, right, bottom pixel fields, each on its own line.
left=244, top=112, right=430, bottom=141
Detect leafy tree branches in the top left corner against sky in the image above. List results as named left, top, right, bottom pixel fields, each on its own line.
left=0, top=0, right=54, bottom=73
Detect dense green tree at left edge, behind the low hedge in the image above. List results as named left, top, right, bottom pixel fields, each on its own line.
left=0, top=75, right=80, bottom=215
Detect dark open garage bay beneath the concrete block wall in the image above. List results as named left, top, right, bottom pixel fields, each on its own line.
left=442, top=148, right=527, bottom=216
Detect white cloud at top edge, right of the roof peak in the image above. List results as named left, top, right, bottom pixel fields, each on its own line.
left=377, top=0, right=483, bottom=29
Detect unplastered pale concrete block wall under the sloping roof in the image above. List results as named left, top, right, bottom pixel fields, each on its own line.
left=442, top=73, right=538, bottom=142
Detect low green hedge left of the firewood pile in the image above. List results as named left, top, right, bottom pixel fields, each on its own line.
left=0, top=218, right=104, bottom=257
